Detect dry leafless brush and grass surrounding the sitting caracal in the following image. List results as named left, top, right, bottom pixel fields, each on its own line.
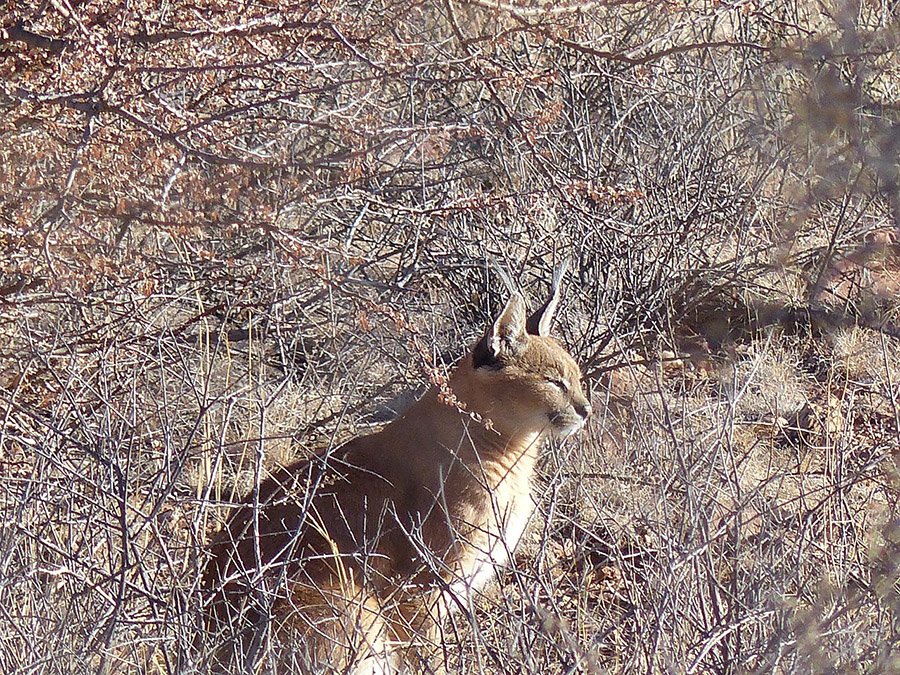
left=0, top=0, right=900, bottom=674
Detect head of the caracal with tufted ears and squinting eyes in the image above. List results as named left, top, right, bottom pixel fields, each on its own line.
left=463, top=278, right=591, bottom=438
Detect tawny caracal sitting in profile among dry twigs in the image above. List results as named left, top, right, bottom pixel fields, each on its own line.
left=204, top=288, right=590, bottom=674
